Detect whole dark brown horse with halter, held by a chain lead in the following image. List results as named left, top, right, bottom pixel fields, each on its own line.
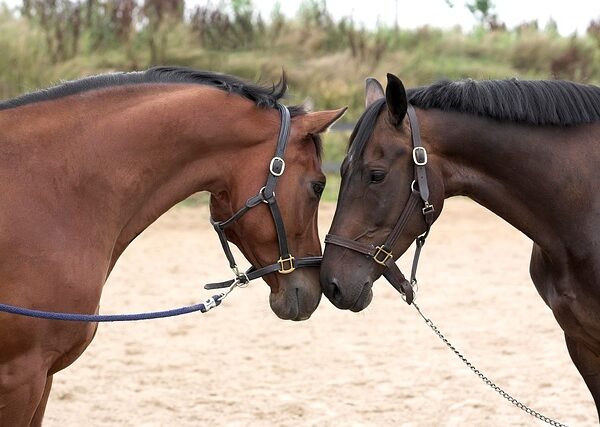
left=321, top=74, right=600, bottom=418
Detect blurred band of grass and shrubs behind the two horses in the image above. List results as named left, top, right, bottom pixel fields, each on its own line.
left=0, top=0, right=600, bottom=198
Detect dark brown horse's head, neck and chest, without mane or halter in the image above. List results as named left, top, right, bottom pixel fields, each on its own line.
left=321, top=75, right=600, bottom=418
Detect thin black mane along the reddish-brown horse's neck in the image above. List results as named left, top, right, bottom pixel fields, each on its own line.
left=0, top=67, right=306, bottom=116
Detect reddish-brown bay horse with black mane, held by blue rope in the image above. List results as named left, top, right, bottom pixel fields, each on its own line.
left=0, top=67, right=344, bottom=427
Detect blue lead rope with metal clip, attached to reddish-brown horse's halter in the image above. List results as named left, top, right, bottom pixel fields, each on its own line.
left=0, top=282, right=237, bottom=322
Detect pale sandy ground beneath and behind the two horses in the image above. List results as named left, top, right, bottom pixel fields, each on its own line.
left=45, top=199, right=597, bottom=427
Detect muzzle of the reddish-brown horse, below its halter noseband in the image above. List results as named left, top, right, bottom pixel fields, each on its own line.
left=269, top=275, right=321, bottom=321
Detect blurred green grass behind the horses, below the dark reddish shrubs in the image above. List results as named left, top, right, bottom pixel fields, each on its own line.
left=0, top=0, right=600, bottom=203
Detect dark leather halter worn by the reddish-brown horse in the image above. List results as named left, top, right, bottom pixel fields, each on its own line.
left=204, top=104, right=321, bottom=289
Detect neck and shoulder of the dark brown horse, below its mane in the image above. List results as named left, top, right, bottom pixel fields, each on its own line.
left=420, top=111, right=600, bottom=378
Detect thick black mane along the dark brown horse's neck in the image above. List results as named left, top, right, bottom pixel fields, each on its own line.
left=407, top=78, right=600, bottom=126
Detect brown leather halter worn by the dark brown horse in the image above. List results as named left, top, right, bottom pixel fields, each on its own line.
left=325, top=104, right=435, bottom=304
